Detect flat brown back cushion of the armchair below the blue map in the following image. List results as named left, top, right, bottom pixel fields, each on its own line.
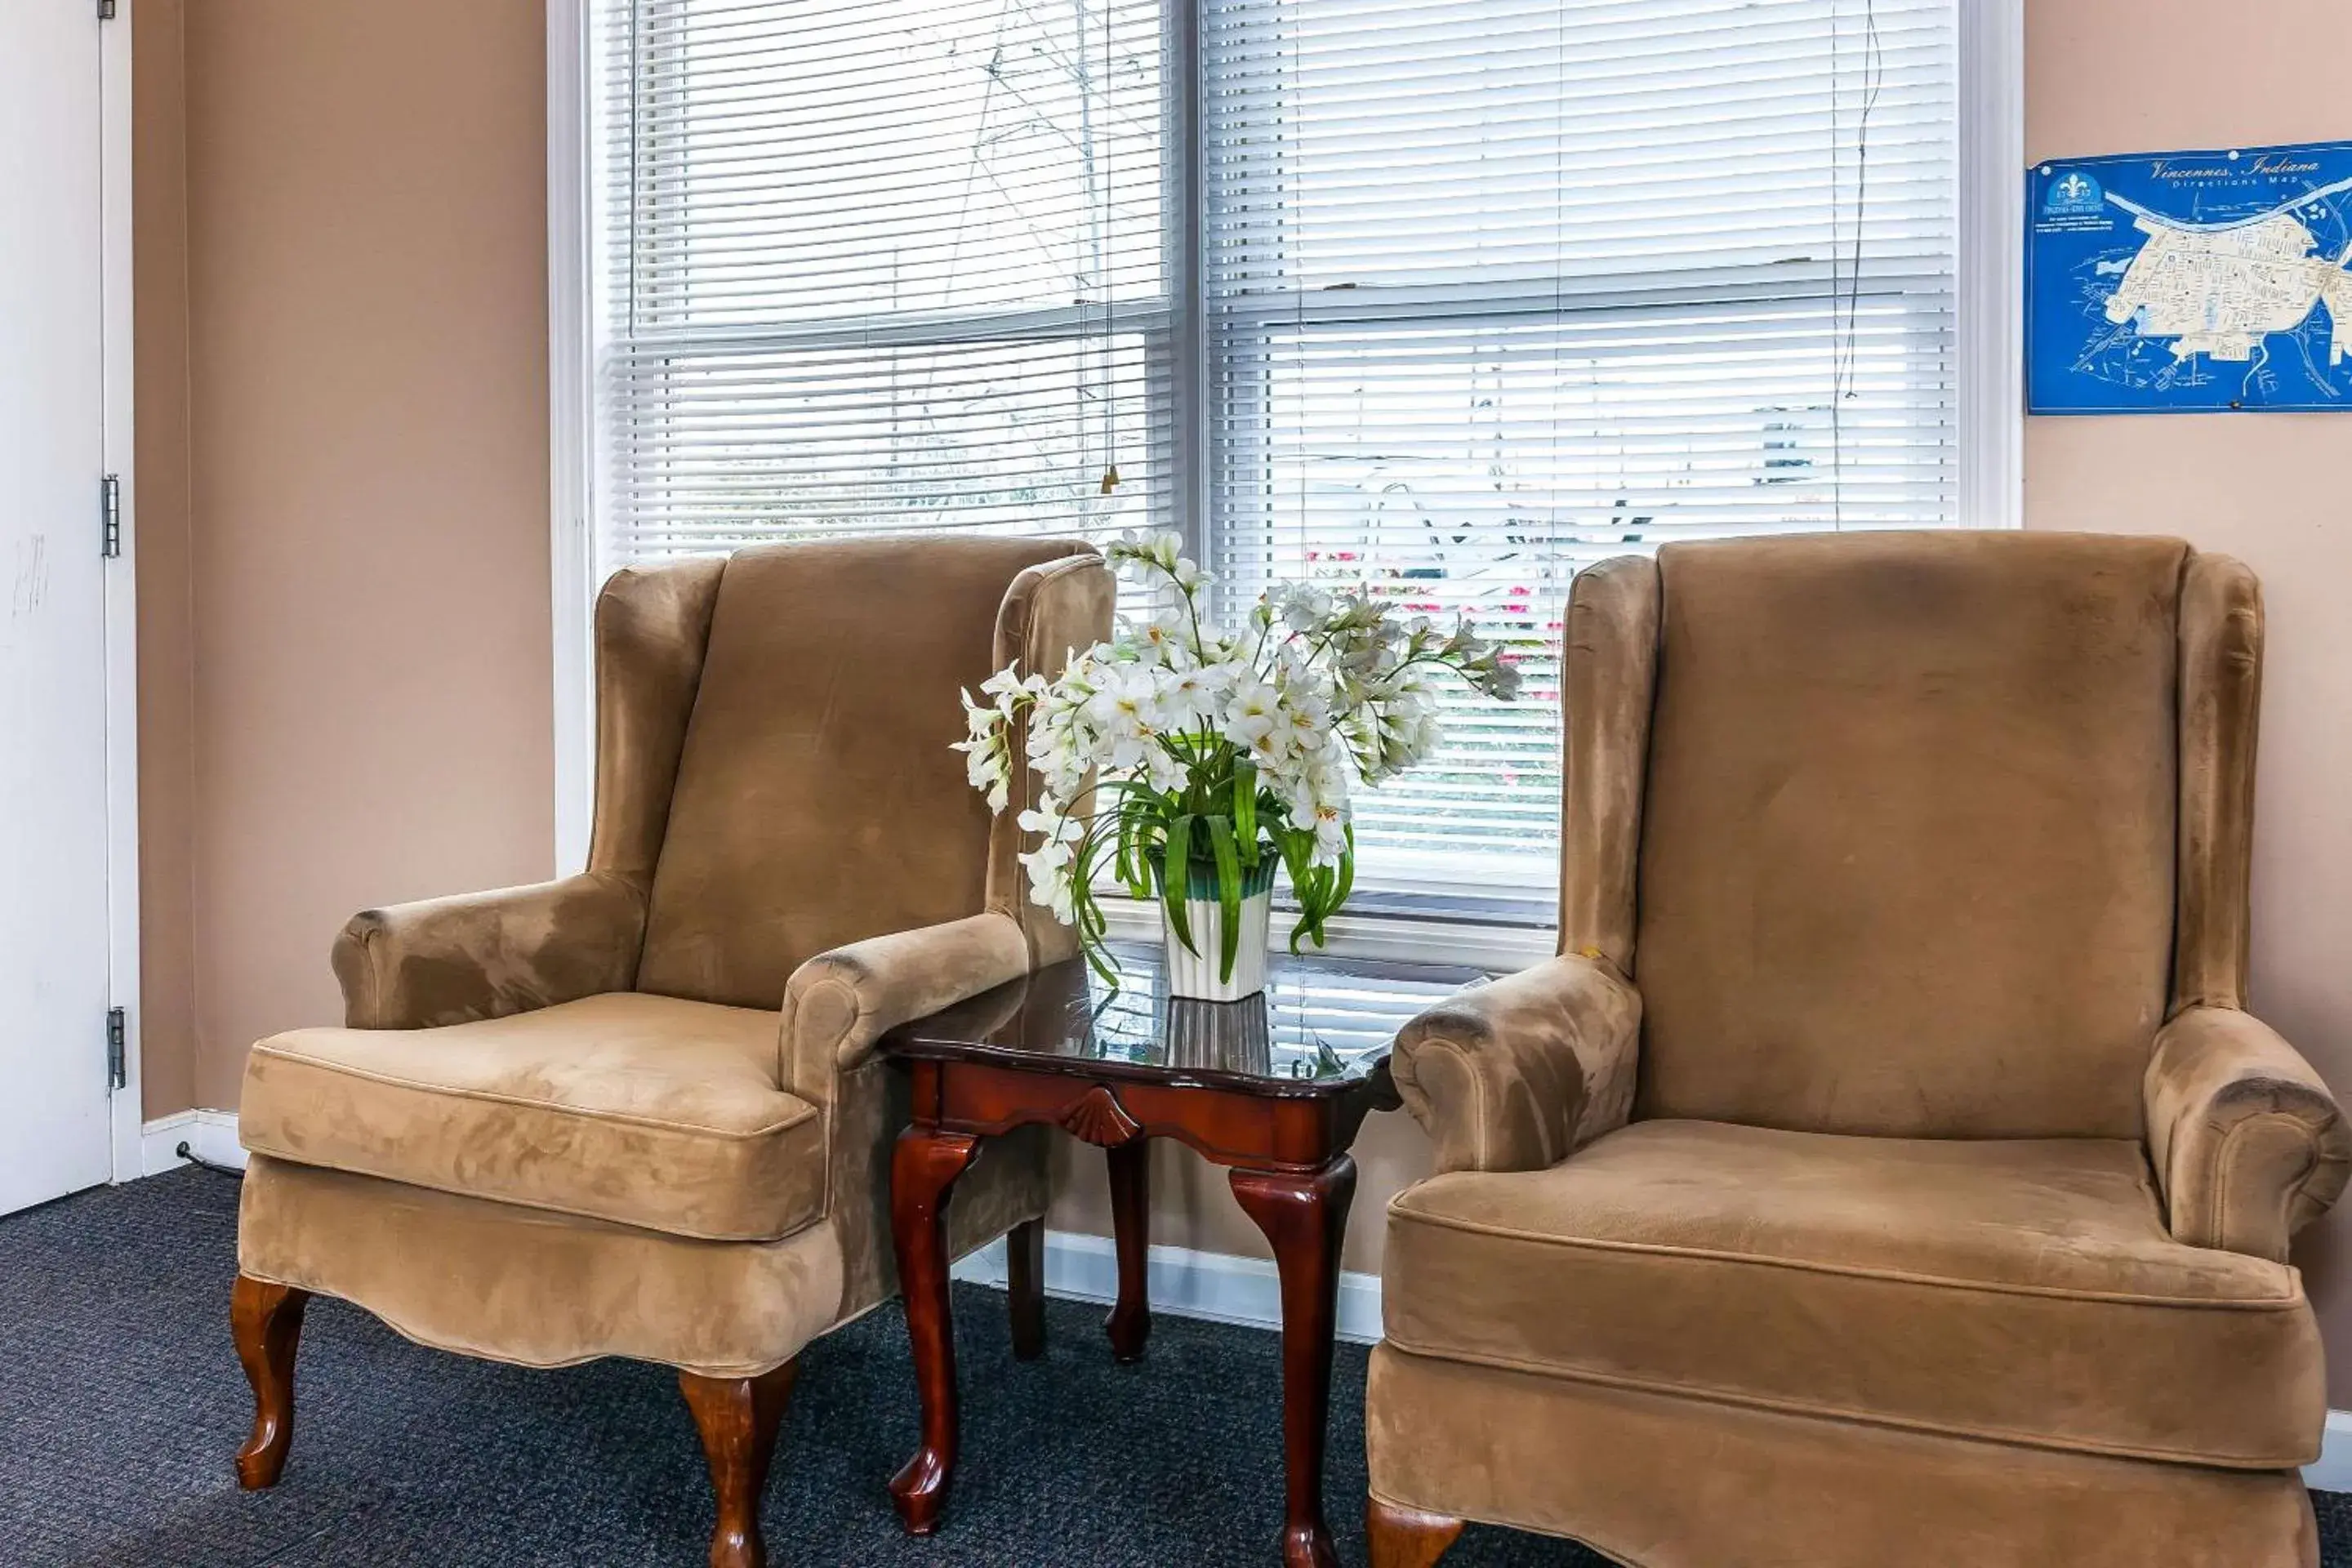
left=1635, top=532, right=2189, bottom=1138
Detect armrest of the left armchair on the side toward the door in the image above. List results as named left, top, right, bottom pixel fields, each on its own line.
left=334, top=872, right=644, bottom=1030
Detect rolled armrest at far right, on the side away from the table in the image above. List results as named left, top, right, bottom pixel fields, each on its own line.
left=2143, top=1006, right=2352, bottom=1263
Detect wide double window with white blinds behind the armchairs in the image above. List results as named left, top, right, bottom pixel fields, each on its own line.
left=559, top=0, right=2016, bottom=917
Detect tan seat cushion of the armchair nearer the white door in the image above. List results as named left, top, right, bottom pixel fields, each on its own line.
left=238, top=992, right=826, bottom=1241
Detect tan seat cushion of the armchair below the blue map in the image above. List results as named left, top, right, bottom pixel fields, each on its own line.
left=1383, top=1121, right=2326, bottom=1467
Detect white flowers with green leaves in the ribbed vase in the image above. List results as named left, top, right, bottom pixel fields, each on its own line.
left=955, top=532, right=1519, bottom=978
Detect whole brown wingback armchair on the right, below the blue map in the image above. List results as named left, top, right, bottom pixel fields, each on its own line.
left=1369, top=533, right=2347, bottom=1568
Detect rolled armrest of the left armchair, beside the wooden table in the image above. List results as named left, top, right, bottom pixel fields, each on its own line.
left=778, top=910, right=1030, bottom=1105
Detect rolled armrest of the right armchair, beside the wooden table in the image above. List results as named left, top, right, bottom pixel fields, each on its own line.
left=1390, top=957, right=1642, bottom=1171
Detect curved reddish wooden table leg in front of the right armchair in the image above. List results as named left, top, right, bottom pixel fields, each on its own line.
left=1230, top=1154, right=1355, bottom=1568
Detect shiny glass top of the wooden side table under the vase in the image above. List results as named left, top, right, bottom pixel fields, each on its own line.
left=880, top=942, right=1494, bottom=1095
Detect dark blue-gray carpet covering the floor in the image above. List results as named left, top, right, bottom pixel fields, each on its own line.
left=0, top=1171, right=2352, bottom=1568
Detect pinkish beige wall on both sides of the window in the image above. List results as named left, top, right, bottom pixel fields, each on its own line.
left=134, top=0, right=2352, bottom=1405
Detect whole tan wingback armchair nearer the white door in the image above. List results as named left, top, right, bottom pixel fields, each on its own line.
left=233, top=538, right=1112, bottom=1568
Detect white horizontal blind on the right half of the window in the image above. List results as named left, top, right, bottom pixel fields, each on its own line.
left=1202, top=0, right=1957, bottom=893
